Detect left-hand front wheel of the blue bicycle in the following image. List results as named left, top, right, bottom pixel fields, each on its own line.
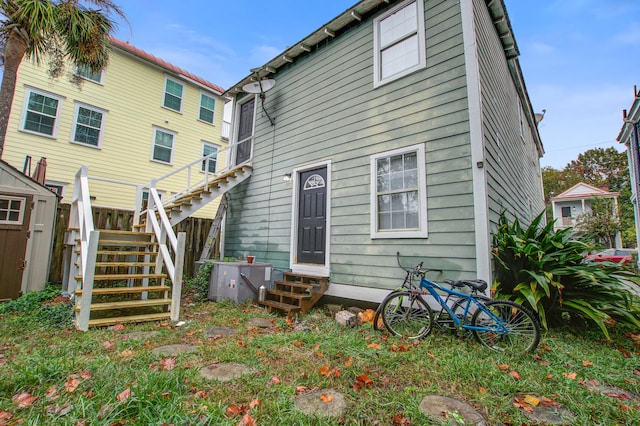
left=380, top=291, right=433, bottom=339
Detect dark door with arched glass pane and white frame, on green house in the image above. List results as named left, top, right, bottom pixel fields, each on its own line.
left=297, top=167, right=327, bottom=265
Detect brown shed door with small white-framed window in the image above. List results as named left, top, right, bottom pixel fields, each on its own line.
left=0, top=193, right=33, bottom=300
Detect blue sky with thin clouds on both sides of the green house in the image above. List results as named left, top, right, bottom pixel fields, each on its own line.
left=107, top=0, right=640, bottom=169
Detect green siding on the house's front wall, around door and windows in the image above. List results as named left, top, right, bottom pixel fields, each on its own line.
left=225, top=0, right=476, bottom=288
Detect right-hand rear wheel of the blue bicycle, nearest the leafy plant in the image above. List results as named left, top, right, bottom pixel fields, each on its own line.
left=471, top=300, right=540, bottom=353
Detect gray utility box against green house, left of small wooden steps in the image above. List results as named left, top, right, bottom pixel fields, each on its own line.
left=208, top=262, right=271, bottom=303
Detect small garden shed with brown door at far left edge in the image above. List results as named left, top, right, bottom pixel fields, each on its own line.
left=0, top=160, right=58, bottom=301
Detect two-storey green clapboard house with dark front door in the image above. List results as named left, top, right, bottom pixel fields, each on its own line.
left=222, top=0, right=544, bottom=301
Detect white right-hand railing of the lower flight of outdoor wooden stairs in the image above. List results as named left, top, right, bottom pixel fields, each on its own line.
left=146, top=180, right=187, bottom=321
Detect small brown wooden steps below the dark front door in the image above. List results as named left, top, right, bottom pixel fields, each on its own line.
left=257, top=272, right=329, bottom=316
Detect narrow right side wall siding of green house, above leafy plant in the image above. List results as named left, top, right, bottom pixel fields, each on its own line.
left=474, top=0, right=544, bottom=231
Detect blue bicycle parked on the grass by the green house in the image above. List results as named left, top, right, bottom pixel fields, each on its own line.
left=374, top=262, right=540, bottom=353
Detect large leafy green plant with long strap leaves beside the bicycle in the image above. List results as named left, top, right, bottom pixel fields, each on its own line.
left=493, top=213, right=640, bottom=338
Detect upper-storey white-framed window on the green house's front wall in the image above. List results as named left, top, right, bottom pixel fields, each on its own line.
left=373, top=0, right=427, bottom=87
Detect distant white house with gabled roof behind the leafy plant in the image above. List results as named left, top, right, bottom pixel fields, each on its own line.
left=551, top=182, right=622, bottom=248
